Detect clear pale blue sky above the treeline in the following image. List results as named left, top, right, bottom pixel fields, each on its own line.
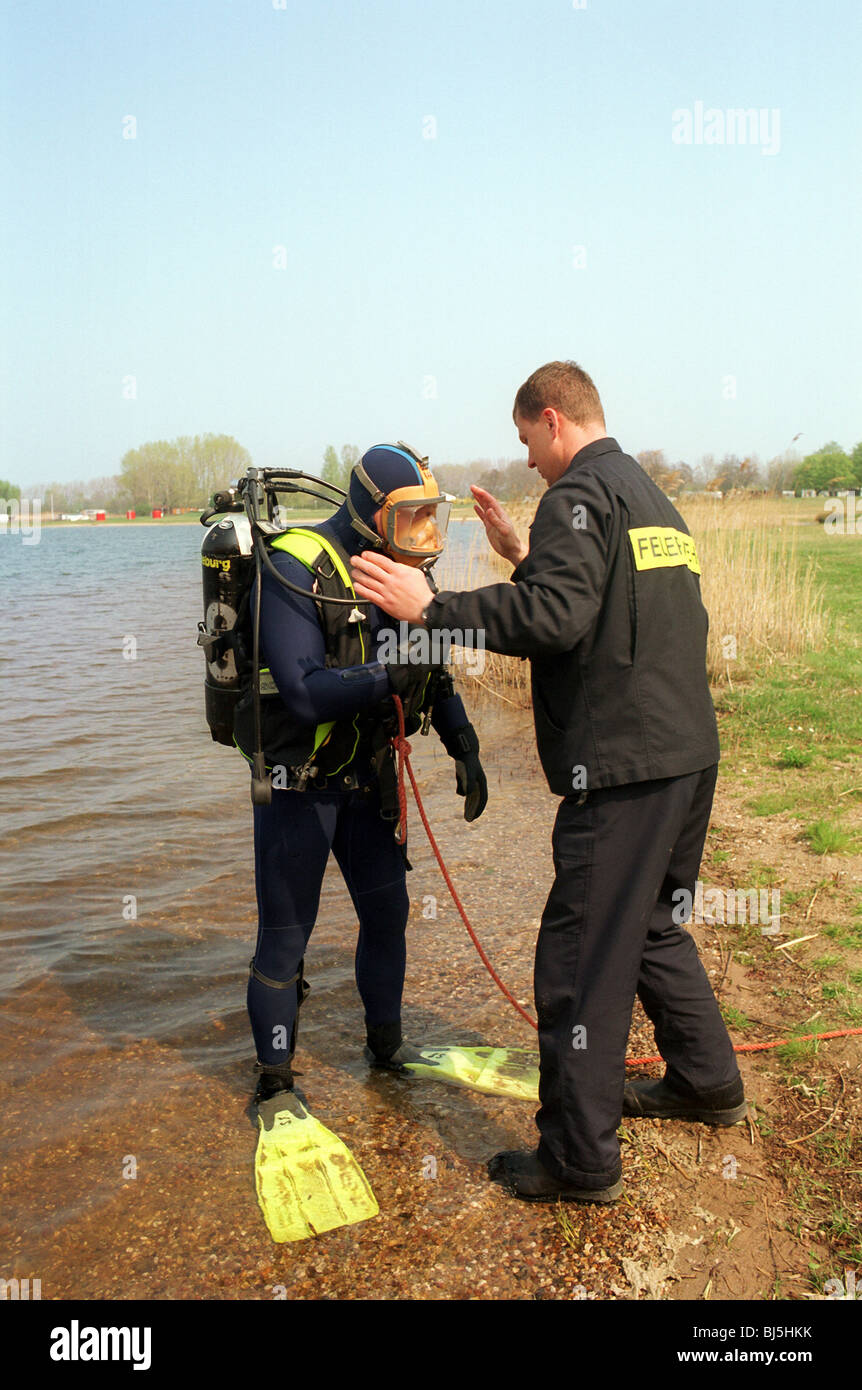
left=0, top=0, right=862, bottom=489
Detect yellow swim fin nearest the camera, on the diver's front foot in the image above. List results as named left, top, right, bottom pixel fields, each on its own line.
left=254, top=1091, right=380, bottom=1243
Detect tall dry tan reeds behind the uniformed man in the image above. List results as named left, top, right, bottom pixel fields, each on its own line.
left=438, top=492, right=827, bottom=709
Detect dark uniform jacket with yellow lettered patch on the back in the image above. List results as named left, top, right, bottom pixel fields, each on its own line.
left=427, top=439, right=719, bottom=796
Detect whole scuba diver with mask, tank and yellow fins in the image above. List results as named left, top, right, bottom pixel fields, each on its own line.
left=197, top=442, right=500, bottom=1241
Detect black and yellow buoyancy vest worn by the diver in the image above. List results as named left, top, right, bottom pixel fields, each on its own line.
left=234, top=527, right=434, bottom=799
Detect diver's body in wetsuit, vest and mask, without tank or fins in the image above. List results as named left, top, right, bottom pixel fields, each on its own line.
left=234, top=443, right=488, bottom=1105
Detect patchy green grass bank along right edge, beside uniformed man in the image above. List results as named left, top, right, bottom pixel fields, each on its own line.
left=670, top=527, right=862, bottom=1278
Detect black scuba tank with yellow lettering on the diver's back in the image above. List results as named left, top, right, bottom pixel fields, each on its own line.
left=197, top=493, right=248, bottom=748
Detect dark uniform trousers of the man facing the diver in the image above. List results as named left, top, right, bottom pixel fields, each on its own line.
left=535, top=766, right=740, bottom=1188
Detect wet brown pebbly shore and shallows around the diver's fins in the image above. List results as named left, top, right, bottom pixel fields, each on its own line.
left=0, top=708, right=672, bottom=1300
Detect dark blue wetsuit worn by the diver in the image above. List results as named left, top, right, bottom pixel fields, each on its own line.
left=247, top=509, right=467, bottom=1066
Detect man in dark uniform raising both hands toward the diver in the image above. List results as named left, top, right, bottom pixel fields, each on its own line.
left=346, top=361, right=745, bottom=1202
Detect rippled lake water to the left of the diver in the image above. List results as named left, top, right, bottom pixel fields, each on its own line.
left=0, top=523, right=511, bottom=1069
